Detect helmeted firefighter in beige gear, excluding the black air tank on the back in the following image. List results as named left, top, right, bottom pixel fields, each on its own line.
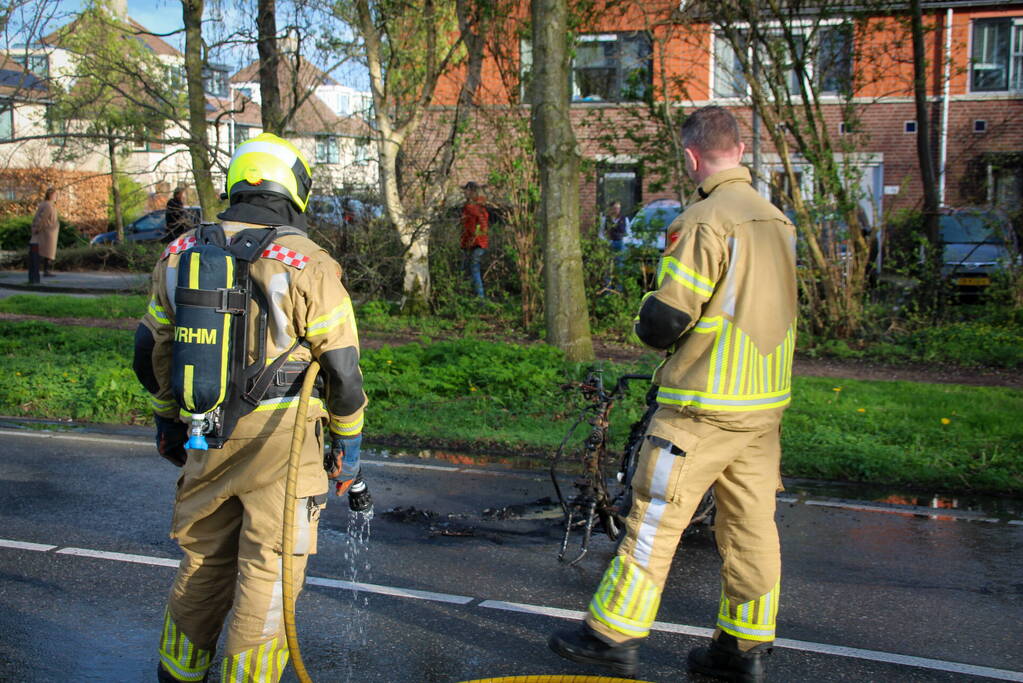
left=135, top=134, right=366, bottom=683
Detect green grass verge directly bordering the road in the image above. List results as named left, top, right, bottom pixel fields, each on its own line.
left=0, top=322, right=1023, bottom=494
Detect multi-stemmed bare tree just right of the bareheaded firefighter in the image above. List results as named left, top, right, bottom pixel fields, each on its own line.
left=714, top=0, right=883, bottom=336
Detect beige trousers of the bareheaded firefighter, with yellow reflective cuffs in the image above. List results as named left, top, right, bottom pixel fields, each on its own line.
left=586, top=408, right=782, bottom=644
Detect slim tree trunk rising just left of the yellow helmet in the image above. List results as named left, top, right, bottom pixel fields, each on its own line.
left=181, top=0, right=220, bottom=221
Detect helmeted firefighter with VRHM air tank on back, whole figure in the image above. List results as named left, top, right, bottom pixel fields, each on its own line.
left=134, top=133, right=371, bottom=682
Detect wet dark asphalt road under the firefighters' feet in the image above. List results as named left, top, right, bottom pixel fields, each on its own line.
left=0, top=430, right=1023, bottom=683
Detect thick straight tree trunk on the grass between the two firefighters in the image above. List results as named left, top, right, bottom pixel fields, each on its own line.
left=530, top=0, right=593, bottom=362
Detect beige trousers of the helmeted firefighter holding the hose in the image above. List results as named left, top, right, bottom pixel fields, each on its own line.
left=160, top=411, right=326, bottom=683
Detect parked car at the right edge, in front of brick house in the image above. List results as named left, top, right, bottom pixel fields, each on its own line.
left=938, top=209, right=1019, bottom=291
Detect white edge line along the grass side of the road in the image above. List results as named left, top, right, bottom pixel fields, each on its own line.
left=0, top=429, right=1023, bottom=526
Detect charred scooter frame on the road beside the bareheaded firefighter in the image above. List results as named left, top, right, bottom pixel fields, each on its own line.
left=549, top=370, right=714, bottom=566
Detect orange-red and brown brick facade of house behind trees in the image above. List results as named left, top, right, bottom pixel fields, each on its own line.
left=415, top=0, right=1023, bottom=231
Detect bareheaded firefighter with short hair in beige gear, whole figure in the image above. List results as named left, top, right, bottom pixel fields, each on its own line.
left=548, top=106, right=797, bottom=681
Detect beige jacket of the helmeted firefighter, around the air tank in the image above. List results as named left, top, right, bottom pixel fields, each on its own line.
left=142, top=222, right=366, bottom=440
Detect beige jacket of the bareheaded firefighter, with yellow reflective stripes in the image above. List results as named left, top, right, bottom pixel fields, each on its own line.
left=648, top=167, right=797, bottom=429
